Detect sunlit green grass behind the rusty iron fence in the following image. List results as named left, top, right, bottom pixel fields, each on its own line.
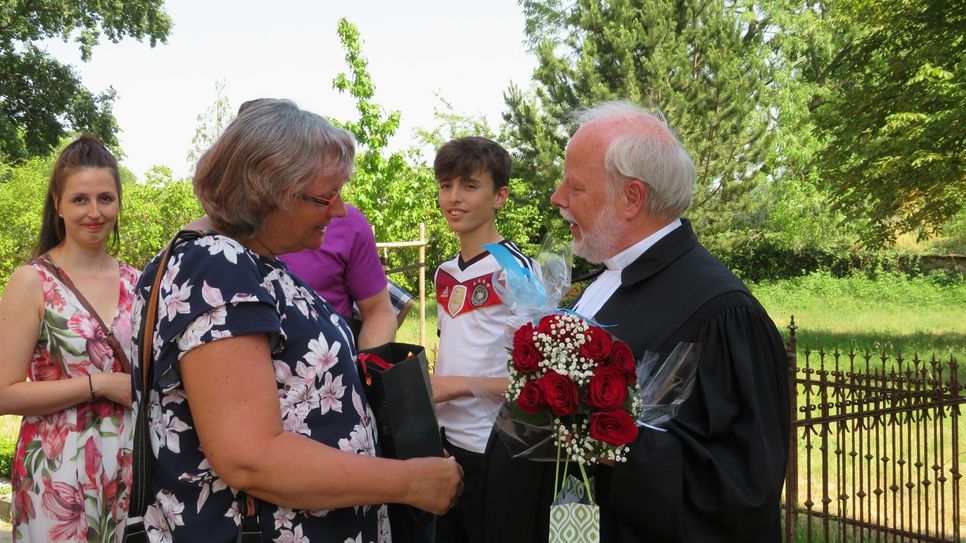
left=749, top=274, right=966, bottom=541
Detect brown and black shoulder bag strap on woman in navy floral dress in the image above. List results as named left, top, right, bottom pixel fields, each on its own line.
left=121, top=230, right=262, bottom=543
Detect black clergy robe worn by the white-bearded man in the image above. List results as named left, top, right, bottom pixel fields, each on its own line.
left=481, top=220, right=789, bottom=543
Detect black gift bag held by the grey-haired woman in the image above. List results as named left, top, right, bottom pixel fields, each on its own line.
left=356, top=343, right=443, bottom=543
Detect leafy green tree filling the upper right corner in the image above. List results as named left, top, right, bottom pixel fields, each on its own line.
left=804, top=0, right=966, bottom=246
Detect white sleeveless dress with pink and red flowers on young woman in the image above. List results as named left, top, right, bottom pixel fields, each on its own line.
left=11, top=263, right=138, bottom=542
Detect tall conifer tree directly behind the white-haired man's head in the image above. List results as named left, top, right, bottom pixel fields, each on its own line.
left=504, top=0, right=792, bottom=236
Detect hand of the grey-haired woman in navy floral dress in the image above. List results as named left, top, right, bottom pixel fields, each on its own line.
left=405, top=457, right=463, bottom=515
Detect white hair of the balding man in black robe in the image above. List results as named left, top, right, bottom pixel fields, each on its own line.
left=577, top=101, right=697, bottom=218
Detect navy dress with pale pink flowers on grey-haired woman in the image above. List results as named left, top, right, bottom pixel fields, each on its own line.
left=132, top=234, right=390, bottom=543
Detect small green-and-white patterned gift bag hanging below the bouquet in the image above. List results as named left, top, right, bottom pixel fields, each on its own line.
left=549, top=472, right=600, bottom=543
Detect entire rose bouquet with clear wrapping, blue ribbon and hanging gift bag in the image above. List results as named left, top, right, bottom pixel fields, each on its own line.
left=484, top=241, right=698, bottom=543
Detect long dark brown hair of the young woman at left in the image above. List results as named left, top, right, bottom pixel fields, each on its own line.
left=33, top=134, right=121, bottom=258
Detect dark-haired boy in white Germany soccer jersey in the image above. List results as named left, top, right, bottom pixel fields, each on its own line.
left=432, top=137, right=530, bottom=543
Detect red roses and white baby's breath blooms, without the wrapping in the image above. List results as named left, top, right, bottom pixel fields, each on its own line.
left=506, top=312, right=641, bottom=464
